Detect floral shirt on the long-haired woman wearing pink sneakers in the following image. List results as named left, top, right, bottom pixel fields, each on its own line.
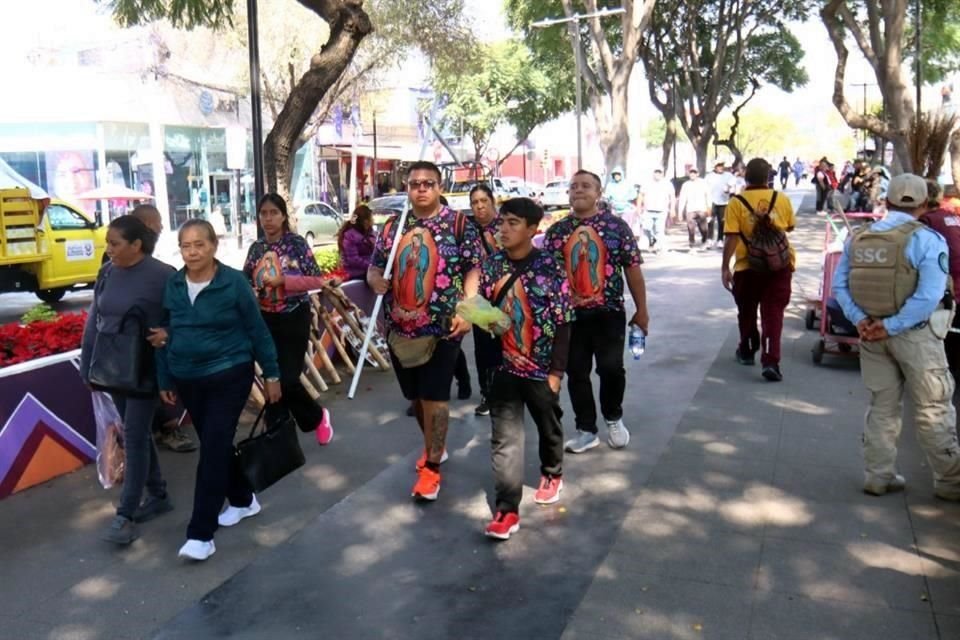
left=243, top=231, right=323, bottom=313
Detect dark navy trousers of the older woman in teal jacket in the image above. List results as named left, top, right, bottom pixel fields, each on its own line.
left=175, top=362, right=253, bottom=541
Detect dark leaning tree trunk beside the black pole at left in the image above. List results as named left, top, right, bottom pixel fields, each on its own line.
left=263, top=2, right=373, bottom=199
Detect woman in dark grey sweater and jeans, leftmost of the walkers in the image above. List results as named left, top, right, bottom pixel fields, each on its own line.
left=80, top=216, right=174, bottom=545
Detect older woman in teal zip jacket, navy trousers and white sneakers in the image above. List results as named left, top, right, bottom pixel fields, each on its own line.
left=155, top=220, right=280, bottom=560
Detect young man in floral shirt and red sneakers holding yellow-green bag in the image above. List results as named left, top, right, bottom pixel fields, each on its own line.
left=480, top=198, right=573, bottom=540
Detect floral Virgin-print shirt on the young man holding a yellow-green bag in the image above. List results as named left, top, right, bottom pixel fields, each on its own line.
left=480, top=251, right=573, bottom=380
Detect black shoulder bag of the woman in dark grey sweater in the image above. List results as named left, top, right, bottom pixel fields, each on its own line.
left=89, top=306, right=157, bottom=396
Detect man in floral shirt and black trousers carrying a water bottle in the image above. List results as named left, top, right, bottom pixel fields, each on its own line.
left=543, top=171, right=650, bottom=453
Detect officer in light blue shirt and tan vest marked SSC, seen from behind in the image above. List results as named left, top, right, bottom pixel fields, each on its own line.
left=833, top=173, right=960, bottom=501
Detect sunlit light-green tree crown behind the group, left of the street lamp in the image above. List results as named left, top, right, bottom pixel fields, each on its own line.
left=433, top=41, right=566, bottom=161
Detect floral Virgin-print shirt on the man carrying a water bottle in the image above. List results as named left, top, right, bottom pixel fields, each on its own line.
left=543, top=213, right=643, bottom=311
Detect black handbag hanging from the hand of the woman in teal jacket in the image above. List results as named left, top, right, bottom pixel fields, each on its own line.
left=235, top=406, right=306, bottom=492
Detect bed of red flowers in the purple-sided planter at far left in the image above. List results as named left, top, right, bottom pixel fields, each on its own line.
left=0, top=311, right=87, bottom=367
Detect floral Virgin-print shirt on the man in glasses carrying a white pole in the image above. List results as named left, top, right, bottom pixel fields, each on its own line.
left=371, top=207, right=483, bottom=338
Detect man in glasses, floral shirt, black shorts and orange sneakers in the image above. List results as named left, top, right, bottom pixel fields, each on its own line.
left=367, top=161, right=483, bottom=500
